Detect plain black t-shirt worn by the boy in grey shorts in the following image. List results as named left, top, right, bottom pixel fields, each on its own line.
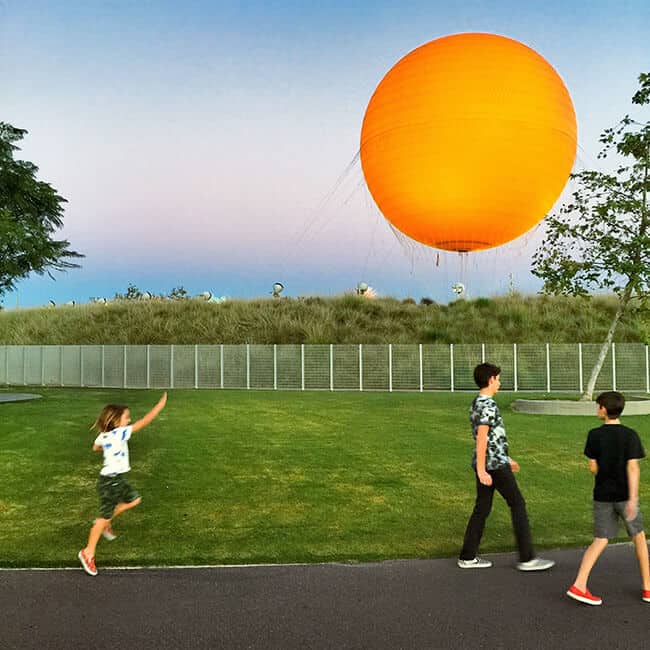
left=585, top=424, right=645, bottom=501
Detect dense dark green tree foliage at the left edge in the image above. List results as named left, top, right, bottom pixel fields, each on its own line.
left=0, top=122, right=84, bottom=296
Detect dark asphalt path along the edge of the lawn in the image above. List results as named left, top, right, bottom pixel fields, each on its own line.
left=0, top=544, right=650, bottom=650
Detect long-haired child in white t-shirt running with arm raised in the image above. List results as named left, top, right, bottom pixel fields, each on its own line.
left=78, top=393, right=167, bottom=576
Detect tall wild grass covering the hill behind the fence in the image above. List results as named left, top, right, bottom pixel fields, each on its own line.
left=0, top=295, right=650, bottom=345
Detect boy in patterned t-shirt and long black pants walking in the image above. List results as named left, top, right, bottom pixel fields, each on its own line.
left=458, top=363, right=555, bottom=571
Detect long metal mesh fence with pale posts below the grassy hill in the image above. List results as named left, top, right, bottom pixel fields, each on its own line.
left=0, top=343, right=650, bottom=392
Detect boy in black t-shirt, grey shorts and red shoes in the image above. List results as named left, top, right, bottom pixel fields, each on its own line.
left=566, top=391, right=650, bottom=605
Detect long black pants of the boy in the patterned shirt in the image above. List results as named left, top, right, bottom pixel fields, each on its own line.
left=460, top=465, right=535, bottom=562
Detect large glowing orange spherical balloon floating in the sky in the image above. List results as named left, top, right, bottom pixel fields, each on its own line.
left=360, top=34, right=577, bottom=251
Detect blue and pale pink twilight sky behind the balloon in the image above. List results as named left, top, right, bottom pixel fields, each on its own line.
left=0, top=0, right=650, bottom=308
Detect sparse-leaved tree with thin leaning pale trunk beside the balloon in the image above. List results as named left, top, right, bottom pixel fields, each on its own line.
left=532, top=73, right=650, bottom=399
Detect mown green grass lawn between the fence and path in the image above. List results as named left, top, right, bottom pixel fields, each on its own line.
left=0, top=388, right=650, bottom=567
